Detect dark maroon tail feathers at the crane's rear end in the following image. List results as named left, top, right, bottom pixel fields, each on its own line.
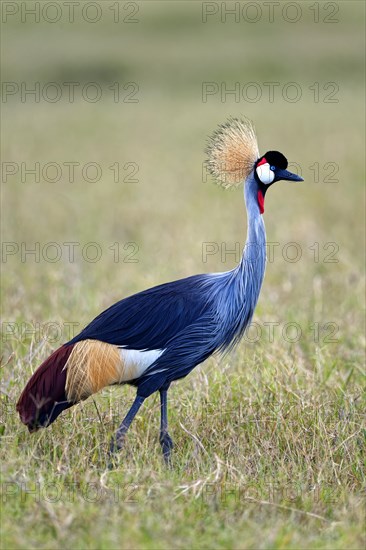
left=17, top=344, right=74, bottom=432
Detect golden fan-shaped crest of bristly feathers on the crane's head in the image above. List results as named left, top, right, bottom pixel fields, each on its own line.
left=206, top=117, right=259, bottom=189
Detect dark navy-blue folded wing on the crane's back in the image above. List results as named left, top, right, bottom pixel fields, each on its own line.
left=69, top=275, right=210, bottom=350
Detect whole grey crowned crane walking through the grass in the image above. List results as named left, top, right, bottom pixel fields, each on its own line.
left=17, top=119, right=302, bottom=466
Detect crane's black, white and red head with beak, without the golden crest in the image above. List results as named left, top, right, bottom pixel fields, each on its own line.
left=254, top=151, right=304, bottom=214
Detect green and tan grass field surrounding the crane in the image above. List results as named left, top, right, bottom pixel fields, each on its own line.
left=0, top=1, right=366, bottom=549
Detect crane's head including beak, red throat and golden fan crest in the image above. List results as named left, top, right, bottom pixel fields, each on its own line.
left=206, top=118, right=303, bottom=214
